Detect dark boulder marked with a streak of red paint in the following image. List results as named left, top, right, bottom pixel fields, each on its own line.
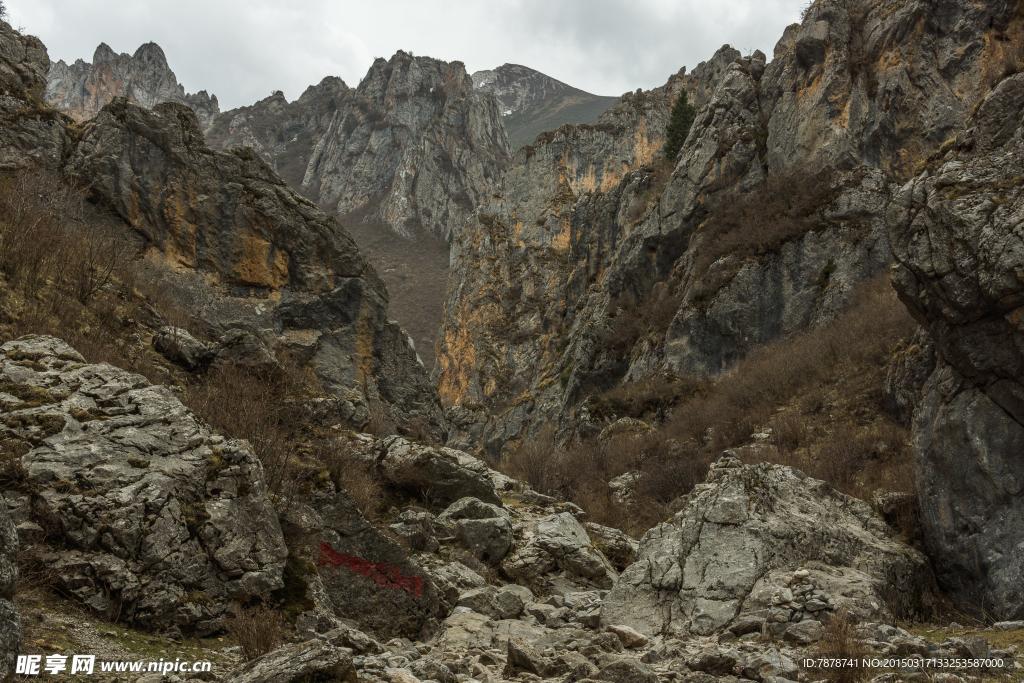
left=283, top=488, right=443, bottom=640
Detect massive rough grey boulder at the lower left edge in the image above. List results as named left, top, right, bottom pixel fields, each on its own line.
left=0, top=337, right=287, bottom=634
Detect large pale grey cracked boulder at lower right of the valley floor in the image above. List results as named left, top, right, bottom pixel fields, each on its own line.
left=601, top=456, right=933, bottom=636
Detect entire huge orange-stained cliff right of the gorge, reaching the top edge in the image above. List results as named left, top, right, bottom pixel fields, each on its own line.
left=434, top=0, right=1015, bottom=452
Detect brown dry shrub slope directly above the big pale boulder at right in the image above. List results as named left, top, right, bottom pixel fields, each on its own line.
left=501, top=276, right=920, bottom=541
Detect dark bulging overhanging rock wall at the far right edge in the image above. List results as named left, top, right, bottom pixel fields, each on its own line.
left=886, top=74, right=1024, bottom=620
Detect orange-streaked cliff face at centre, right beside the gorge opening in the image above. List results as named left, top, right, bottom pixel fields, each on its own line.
left=433, top=69, right=685, bottom=455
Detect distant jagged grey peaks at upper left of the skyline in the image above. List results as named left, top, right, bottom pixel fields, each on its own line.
left=46, top=43, right=220, bottom=128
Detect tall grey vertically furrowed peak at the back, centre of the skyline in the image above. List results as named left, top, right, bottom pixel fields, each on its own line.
left=302, top=50, right=510, bottom=239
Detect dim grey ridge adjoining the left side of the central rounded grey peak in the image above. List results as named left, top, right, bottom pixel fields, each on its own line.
left=205, top=76, right=351, bottom=194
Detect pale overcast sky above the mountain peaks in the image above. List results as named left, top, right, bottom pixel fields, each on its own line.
left=5, top=0, right=806, bottom=111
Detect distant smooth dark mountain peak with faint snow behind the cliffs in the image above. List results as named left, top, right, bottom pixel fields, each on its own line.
left=472, top=63, right=616, bottom=150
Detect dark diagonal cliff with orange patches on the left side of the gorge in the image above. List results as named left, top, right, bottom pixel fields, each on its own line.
left=66, top=98, right=445, bottom=436
